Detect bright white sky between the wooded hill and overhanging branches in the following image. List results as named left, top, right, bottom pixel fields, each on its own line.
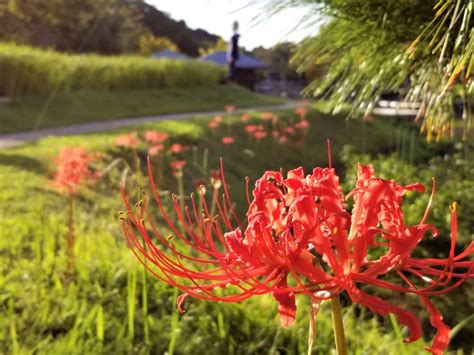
left=146, top=0, right=318, bottom=49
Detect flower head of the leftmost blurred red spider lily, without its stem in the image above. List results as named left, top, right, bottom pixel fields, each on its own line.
left=54, top=148, right=99, bottom=194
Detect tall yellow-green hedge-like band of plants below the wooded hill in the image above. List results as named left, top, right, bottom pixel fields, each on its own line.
left=0, top=43, right=224, bottom=97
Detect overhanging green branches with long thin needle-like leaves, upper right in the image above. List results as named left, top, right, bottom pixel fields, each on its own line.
left=272, top=0, right=474, bottom=142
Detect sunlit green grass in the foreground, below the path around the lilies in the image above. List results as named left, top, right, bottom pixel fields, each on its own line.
left=0, top=112, right=442, bottom=354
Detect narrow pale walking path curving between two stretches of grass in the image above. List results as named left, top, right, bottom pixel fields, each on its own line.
left=0, top=101, right=301, bottom=149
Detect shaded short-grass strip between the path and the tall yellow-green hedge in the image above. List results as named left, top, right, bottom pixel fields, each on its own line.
left=0, top=85, right=284, bottom=134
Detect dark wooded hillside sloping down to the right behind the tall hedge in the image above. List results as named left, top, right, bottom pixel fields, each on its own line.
left=0, top=0, right=219, bottom=56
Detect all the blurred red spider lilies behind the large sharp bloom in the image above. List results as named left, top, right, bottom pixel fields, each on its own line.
left=53, top=105, right=309, bottom=274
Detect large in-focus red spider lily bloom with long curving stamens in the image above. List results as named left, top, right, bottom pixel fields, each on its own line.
left=122, top=163, right=474, bottom=354
